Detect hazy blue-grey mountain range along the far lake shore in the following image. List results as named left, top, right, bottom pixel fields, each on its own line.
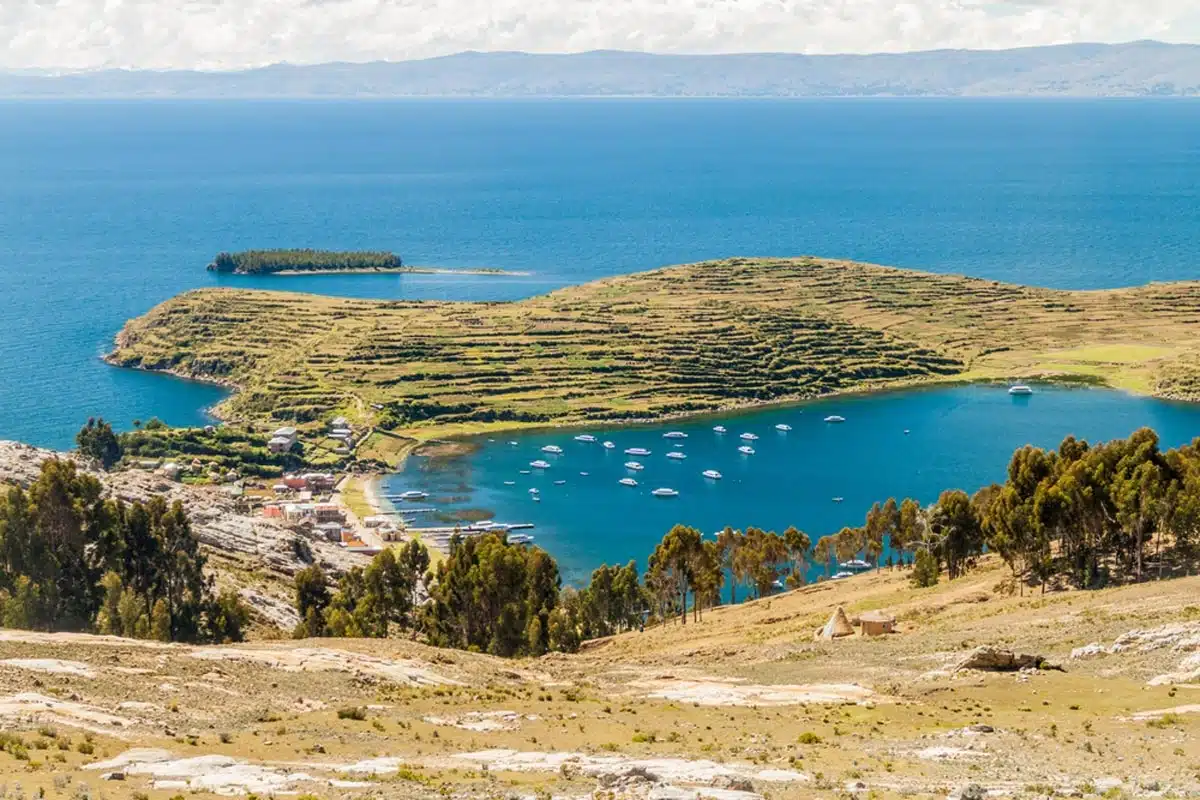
left=0, top=42, right=1200, bottom=97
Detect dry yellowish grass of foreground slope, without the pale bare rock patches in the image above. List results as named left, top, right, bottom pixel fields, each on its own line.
left=0, top=559, right=1200, bottom=800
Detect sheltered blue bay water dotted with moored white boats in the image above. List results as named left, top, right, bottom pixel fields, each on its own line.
left=388, top=386, right=1200, bottom=581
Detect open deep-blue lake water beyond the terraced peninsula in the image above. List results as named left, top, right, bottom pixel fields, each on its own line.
left=0, top=100, right=1200, bottom=450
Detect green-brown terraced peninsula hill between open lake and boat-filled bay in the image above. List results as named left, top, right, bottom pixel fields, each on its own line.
left=109, top=258, right=1200, bottom=435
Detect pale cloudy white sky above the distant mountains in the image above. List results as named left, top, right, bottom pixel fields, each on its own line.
left=7, top=0, right=1200, bottom=70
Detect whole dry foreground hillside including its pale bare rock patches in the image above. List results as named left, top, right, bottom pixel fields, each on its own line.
left=0, top=560, right=1200, bottom=800
